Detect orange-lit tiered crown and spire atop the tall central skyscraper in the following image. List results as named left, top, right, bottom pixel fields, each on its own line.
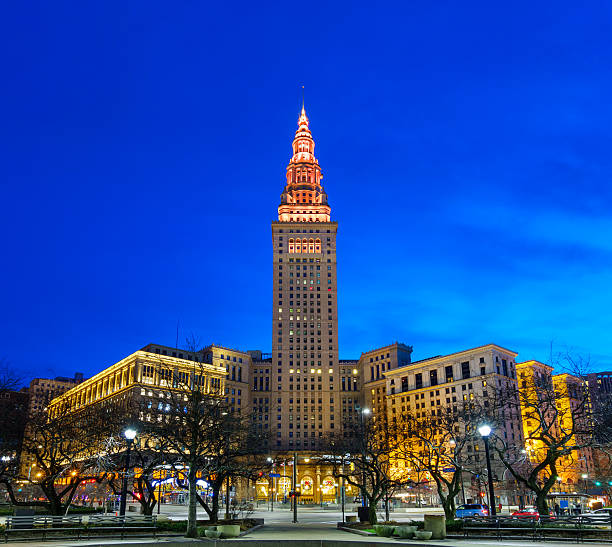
left=278, top=105, right=330, bottom=222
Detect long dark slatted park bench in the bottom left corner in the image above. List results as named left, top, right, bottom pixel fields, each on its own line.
left=4, top=514, right=157, bottom=543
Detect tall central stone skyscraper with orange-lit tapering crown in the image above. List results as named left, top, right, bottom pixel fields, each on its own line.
left=270, top=106, right=341, bottom=450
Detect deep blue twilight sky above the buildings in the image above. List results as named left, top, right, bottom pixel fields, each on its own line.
left=0, top=0, right=612, bottom=384
